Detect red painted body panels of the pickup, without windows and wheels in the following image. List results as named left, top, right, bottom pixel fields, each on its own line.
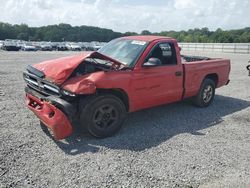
left=24, top=36, right=230, bottom=138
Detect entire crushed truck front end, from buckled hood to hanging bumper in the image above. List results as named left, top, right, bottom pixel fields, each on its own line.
left=23, top=52, right=125, bottom=140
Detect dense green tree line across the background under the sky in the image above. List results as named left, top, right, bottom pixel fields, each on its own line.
left=0, top=22, right=250, bottom=43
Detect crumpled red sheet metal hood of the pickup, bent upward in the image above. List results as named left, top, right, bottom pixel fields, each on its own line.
left=33, top=52, right=122, bottom=85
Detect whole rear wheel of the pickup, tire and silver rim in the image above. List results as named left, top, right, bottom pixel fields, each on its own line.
left=193, top=78, right=215, bottom=107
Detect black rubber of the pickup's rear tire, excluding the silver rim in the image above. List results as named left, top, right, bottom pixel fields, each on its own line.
left=192, top=78, right=215, bottom=107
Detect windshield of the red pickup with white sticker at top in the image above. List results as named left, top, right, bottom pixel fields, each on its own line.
left=98, top=39, right=148, bottom=67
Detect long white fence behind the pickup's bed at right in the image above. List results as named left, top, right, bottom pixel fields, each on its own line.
left=179, top=43, right=250, bottom=54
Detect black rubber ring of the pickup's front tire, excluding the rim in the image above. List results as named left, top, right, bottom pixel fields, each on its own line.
left=80, top=94, right=127, bottom=138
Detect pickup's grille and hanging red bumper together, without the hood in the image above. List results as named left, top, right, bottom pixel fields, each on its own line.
left=24, top=73, right=77, bottom=140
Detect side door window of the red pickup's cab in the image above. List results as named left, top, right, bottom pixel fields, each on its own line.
left=146, top=43, right=177, bottom=66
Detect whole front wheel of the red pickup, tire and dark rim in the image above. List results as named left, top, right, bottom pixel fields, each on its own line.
left=80, top=95, right=126, bottom=138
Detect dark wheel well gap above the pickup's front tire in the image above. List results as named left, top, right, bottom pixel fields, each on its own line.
left=97, top=89, right=129, bottom=112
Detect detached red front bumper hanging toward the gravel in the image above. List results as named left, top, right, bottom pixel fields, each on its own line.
left=25, top=89, right=75, bottom=140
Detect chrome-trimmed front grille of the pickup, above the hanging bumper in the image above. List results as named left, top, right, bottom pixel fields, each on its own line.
left=23, top=72, right=61, bottom=96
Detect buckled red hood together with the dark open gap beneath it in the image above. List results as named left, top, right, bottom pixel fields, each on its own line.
left=33, top=52, right=124, bottom=86
